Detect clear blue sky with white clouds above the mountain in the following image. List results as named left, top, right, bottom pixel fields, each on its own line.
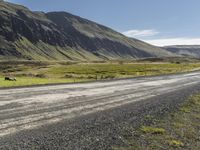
left=4, top=0, right=200, bottom=46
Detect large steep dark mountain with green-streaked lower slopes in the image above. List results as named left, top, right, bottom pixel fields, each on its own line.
left=0, top=0, right=174, bottom=61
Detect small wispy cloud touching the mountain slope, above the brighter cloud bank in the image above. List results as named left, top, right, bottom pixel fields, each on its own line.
left=122, top=29, right=159, bottom=38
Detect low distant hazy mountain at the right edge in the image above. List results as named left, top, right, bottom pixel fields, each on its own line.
left=163, top=45, right=200, bottom=58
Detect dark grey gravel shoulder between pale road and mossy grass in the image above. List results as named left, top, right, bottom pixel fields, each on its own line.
left=0, top=85, right=200, bottom=150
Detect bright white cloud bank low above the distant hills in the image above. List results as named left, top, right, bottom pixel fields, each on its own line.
left=144, top=37, right=200, bottom=46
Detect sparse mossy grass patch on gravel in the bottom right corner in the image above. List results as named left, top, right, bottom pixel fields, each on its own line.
left=113, top=95, right=200, bottom=150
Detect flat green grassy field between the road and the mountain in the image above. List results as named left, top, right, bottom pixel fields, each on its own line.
left=0, top=61, right=200, bottom=87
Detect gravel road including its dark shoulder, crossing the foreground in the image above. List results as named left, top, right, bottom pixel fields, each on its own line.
left=0, top=72, right=200, bottom=150
